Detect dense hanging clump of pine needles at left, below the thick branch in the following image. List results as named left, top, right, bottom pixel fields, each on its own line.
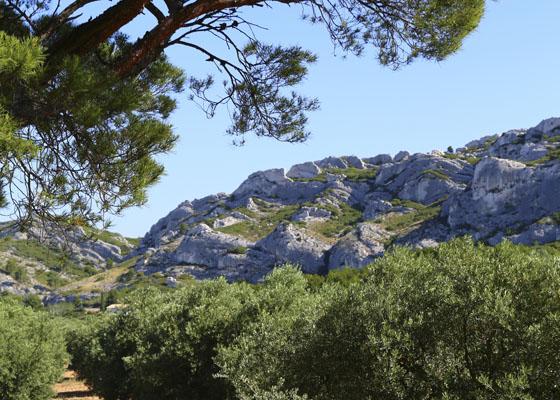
left=0, top=28, right=184, bottom=227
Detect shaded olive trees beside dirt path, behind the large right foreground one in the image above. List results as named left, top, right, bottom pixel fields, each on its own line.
left=69, top=269, right=312, bottom=400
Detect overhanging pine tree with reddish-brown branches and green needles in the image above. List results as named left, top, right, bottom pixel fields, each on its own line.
left=0, top=0, right=484, bottom=223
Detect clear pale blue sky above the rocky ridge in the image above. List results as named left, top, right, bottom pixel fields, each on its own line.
left=106, top=0, right=560, bottom=236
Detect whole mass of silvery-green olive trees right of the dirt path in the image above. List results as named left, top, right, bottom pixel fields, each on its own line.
left=70, top=239, right=560, bottom=400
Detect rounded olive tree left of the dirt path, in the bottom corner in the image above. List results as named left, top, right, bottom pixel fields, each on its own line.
left=0, top=297, right=67, bottom=400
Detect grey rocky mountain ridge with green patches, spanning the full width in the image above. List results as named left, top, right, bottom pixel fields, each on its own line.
left=0, top=118, right=560, bottom=301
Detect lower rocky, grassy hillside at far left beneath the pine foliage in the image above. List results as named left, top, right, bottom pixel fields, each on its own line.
left=0, top=221, right=135, bottom=302
